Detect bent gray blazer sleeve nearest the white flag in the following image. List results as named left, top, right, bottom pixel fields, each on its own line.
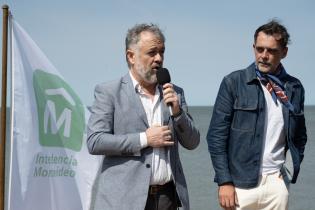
left=87, top=85, right=141, bottom=156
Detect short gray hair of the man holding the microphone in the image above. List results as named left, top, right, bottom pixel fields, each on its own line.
left=125, top=23, right=165, bottom=67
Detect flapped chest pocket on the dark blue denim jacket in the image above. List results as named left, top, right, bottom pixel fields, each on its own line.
left=232, top=98, right=258, bottom=131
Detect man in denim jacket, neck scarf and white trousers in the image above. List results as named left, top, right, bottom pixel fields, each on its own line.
left=207, top=20, right=307, bottom=210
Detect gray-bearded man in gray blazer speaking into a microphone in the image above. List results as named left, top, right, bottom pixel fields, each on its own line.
left=87, top=24, right=200, bottom=210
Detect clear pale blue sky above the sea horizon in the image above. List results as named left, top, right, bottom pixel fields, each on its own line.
left=0, top=0, right=315, bottom=106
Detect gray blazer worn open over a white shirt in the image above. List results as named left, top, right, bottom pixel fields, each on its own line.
left=87, top=74, right=200, bottom=210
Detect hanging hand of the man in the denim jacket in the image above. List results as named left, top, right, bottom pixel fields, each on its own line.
left=218, top=183, right=238, bottom=210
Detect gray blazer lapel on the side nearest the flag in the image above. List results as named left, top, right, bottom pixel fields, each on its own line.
left=122, top=73, right=149, bottom=127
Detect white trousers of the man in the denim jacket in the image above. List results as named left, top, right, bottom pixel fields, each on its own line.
left=235, top=173, right=289, bottom=210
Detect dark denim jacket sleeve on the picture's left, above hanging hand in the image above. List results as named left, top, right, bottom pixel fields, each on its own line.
left=207, top=77, right=235, bottom=185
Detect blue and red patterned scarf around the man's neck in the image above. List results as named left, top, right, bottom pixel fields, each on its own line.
left=256, top=64, right=294, bottom=111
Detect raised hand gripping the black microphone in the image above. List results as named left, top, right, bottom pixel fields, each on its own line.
left=163, top=83, right=180, bottom=115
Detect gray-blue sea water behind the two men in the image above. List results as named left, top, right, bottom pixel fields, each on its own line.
left=180, top=106, right=315, bottom=210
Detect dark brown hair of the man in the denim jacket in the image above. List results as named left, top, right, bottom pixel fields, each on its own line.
left=254, top=19, right=291, bottom=48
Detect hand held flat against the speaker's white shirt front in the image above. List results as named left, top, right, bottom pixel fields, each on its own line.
left=145, top=126, right=174, bottom=147
